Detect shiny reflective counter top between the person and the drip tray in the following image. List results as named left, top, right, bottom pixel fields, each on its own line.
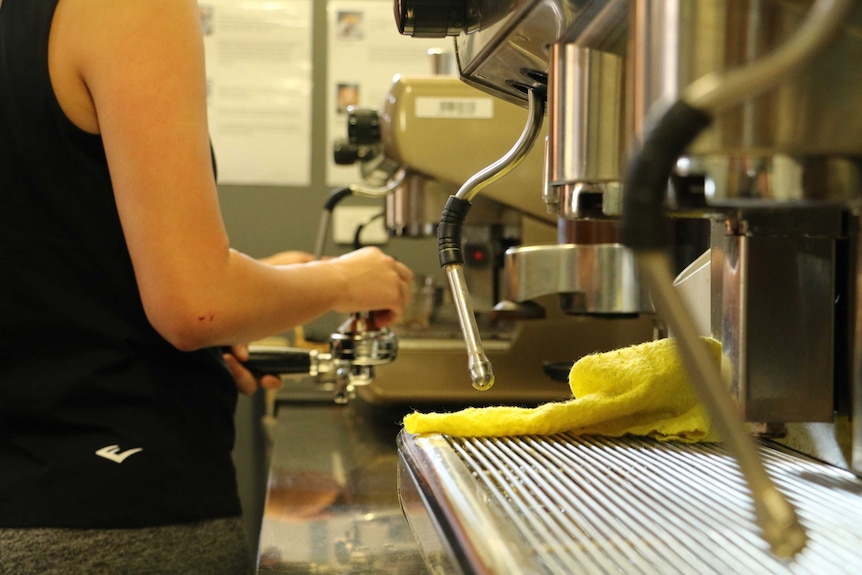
left=258, top=400, right=427, bottom=575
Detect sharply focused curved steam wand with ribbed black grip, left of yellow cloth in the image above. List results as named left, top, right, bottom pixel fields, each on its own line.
left=437, top=89, right=545, bottom=391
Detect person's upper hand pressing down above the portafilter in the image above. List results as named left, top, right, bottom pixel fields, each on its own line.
left=326, top=247, right=413, bottom=327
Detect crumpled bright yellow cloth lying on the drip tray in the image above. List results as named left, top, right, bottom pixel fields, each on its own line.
left=404, top=338, right=721, bottom=442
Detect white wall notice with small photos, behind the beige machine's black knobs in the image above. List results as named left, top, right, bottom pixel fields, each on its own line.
left=327, top=0, right=454, bottom=185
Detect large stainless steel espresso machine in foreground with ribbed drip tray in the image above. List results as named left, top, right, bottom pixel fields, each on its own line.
left=395, top=0, right=862, bottom=573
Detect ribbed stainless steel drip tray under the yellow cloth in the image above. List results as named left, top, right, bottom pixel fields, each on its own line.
left=398, top=432, right=862, bottom=575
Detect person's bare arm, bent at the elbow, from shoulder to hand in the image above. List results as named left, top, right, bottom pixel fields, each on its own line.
left=52, top=0, right=412, bottom=350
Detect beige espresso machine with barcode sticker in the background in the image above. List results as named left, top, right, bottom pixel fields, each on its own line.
left=324, top=72, right=655, bottom=406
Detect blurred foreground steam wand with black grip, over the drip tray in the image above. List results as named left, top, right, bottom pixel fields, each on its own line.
left=621, top=0, right=855, bottom=557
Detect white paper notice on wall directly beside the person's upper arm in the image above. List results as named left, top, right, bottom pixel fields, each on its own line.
left=200, top=0, right=312, bottom=186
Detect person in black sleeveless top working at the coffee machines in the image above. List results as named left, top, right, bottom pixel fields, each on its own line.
left=0, top=0, right=412, bottom=575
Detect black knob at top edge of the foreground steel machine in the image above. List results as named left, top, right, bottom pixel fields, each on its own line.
left=394, top=0, right=468, bottom=38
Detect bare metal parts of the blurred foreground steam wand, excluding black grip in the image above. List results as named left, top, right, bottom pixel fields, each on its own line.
left=627, top=0, right=855, bottom=557
